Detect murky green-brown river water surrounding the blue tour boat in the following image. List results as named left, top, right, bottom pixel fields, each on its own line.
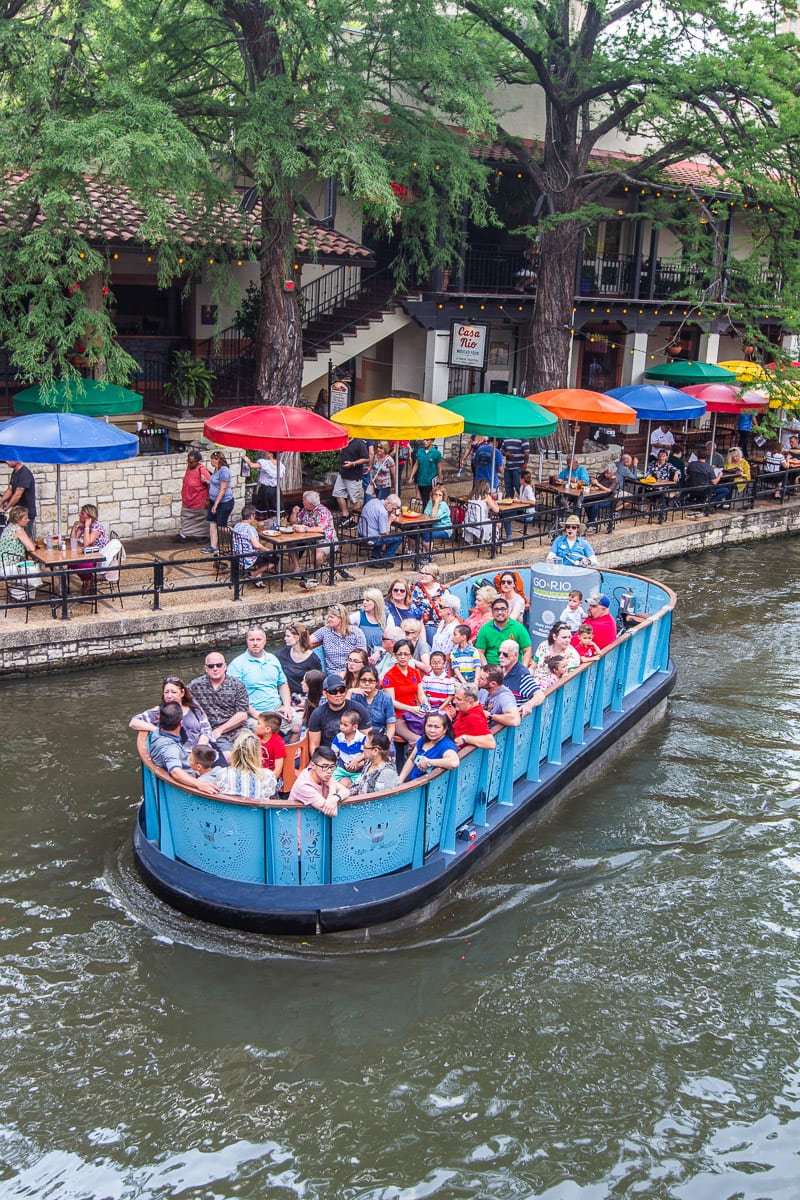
left=0, top=539, right=800, bottom=1200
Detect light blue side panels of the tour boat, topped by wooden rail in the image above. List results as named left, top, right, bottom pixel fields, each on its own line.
left=138, top=571, right=675, bottom=887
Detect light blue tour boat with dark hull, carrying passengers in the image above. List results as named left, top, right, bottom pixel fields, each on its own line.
left=133, top=564, right=675, bottom=935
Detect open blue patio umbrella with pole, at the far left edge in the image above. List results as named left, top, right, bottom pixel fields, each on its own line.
left=0, top=412, right=139, bottom=536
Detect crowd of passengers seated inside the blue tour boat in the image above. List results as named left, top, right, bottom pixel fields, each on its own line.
left=139, top=583, right=616, bottom=815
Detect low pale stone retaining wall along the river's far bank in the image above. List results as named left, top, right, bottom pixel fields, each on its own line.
left=6, top=500, right=800, bottom=678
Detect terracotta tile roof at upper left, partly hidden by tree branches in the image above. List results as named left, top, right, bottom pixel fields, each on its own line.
left=0, top=174, right=372, bottom=262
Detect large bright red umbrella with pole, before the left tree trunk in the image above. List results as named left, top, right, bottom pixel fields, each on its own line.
left=203, top=404, right=349, bottom=515
